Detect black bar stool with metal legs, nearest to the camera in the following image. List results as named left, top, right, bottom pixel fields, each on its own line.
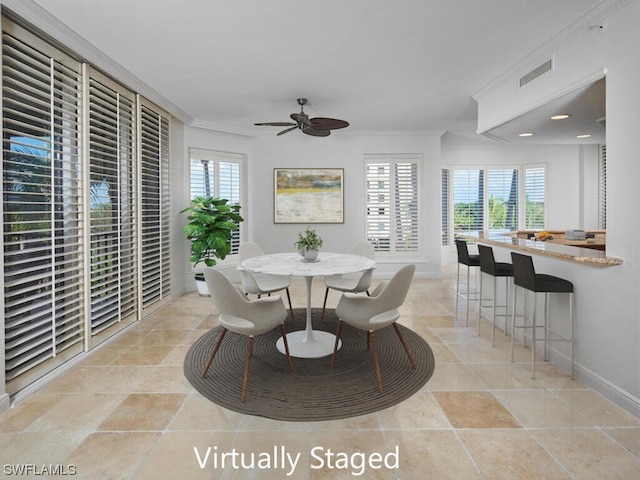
left=511, top=252, right=574, bottom=379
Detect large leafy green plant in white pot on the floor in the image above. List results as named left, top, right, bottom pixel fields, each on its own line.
left=180, top=197, right=244, bottom=294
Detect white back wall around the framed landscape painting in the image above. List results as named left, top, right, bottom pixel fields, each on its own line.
left=245, top=132, right=441, bottom=277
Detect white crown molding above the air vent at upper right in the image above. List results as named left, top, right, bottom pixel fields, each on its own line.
left=471, top=0, right=633, bottom=100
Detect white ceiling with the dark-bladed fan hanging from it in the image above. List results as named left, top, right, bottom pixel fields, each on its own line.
left=35, top=0, right=600, bottom=141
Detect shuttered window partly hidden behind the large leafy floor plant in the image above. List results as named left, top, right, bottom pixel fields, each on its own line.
left=189, top=148, right=245, bottom=254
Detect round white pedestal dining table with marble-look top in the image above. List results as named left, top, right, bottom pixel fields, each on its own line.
left=238, top=252, right=376, bottom=358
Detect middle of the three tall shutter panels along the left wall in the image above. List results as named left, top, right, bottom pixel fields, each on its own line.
left=88, top=71, right=137, bottom=342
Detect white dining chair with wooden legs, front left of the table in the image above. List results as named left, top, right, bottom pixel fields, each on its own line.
left=202, top=267, right=293, bottom=402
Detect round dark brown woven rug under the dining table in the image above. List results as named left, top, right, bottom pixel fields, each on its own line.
left=184, top=308, right=435, bottom=422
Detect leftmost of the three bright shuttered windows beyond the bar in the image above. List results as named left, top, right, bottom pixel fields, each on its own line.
left=453, top=169, right=484, bottom=232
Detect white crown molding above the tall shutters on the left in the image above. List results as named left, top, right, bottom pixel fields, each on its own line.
left=0, top=0, right=193, bottom=124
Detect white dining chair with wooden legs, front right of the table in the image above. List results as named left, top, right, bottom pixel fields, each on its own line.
left=331, top=265, right=416, bottom=392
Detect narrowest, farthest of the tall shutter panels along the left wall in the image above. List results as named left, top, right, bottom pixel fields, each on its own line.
left=139, top=99, right=171, bottom=310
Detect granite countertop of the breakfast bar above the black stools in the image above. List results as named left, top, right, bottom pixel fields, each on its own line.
left=456, top=230, right=623, bottom=267
